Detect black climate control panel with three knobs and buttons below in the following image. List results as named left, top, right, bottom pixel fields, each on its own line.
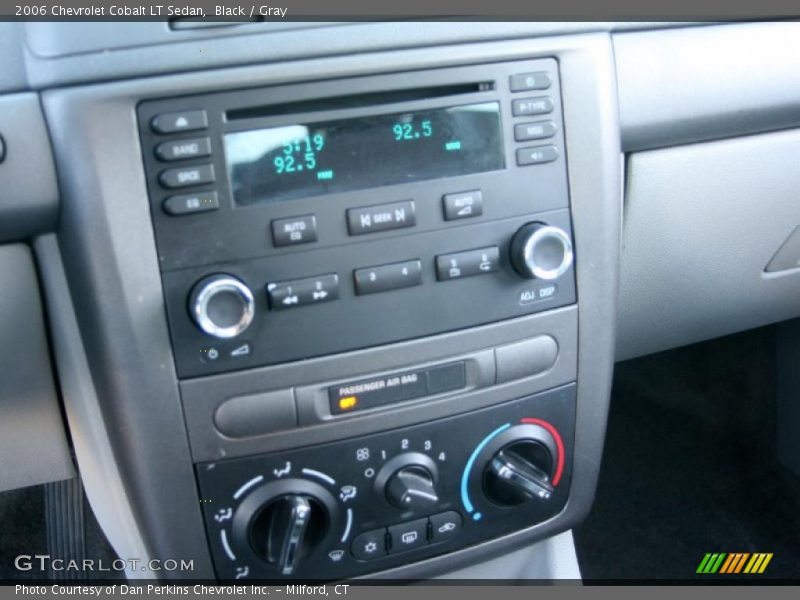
left=196, top=385, right=575, bottom=581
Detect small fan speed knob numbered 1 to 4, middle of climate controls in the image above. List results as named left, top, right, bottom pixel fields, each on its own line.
left=375, top=452, right=439, bottom=511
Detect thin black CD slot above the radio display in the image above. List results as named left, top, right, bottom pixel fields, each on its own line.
left=225, top=81, right=494, bottom=121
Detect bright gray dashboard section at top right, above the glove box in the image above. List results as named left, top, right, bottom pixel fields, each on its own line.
left=613, top=21, right=800, bottom=151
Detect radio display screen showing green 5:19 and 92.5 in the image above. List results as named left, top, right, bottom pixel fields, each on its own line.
left=225, top=102, right=505, bottom=206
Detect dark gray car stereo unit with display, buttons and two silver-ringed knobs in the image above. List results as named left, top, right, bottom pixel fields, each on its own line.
left=138, top=59, right=575, bottom=377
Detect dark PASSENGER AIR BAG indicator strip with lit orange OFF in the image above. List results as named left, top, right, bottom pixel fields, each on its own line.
left=328, top=361, right=466, bottom=415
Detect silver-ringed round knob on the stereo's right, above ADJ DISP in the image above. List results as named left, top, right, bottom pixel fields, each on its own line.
left=509, top=223, right=573, bottom=280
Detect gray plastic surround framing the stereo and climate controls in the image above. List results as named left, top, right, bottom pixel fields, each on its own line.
left=43, top=31, right=621, bottom=577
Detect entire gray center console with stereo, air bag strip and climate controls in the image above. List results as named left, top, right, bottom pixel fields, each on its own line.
left=40, top=35, right=620, bottom=581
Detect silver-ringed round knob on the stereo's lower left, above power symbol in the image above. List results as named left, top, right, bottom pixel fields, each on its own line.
left=189, top=274, right=255, bottom=339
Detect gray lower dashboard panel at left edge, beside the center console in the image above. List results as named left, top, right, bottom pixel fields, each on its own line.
left=0, top=244, right=75, bottom=491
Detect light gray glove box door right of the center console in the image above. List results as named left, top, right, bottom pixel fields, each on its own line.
left=617, top=130, right=800, bottom=359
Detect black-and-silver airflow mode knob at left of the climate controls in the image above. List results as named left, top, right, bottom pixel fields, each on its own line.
left=233, top=479, right=339, bottom=575
